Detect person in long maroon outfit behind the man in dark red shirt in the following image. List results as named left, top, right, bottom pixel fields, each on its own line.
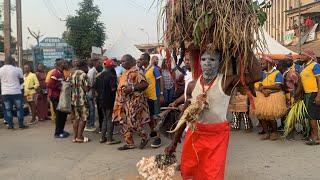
left=36, top=64, right=50, bottom=121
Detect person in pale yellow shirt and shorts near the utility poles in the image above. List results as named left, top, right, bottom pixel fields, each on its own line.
left=24, top=65, right=40, bottom=125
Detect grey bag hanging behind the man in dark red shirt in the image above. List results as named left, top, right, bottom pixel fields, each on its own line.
left=57, top=81, right=71, bottom=113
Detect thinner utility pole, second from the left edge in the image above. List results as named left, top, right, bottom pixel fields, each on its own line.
left=16, top=0, right=23, bottom=68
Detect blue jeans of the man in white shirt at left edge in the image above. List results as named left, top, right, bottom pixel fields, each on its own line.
left=2, top=94, right=24, bottom=127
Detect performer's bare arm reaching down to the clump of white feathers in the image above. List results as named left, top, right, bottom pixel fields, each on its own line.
left=165, top=79, right=197, bottom=154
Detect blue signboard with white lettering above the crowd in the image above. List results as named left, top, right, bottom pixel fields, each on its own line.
left=32, top=37, right=74, bottom=69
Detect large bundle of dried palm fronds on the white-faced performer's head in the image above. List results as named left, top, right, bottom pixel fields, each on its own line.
left=158, top=0, right=270, bottom=70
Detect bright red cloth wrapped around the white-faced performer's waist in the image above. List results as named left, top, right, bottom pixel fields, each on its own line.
left=181, top=121, right=230, bottom=180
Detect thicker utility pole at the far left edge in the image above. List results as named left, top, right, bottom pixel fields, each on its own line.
left=3, top=0, right=11, bottom=57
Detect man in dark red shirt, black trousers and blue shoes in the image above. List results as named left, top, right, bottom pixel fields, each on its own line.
left=48, top=58, right=70, bottom=138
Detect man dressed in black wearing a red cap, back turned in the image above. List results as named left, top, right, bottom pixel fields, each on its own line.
left=94, top=59, right=120, bottom=144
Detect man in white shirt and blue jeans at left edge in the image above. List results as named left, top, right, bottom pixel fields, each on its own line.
left=0, top=56, right=28, bottom=130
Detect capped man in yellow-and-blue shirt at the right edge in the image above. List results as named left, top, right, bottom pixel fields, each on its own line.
left=300, top=51, right=320, bottom=145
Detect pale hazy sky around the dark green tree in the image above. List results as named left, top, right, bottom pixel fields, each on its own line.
left=11, top=0, right=159, bottom=48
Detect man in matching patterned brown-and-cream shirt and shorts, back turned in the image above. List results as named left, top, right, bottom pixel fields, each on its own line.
left=71, top=61, right=90, bottom=143
